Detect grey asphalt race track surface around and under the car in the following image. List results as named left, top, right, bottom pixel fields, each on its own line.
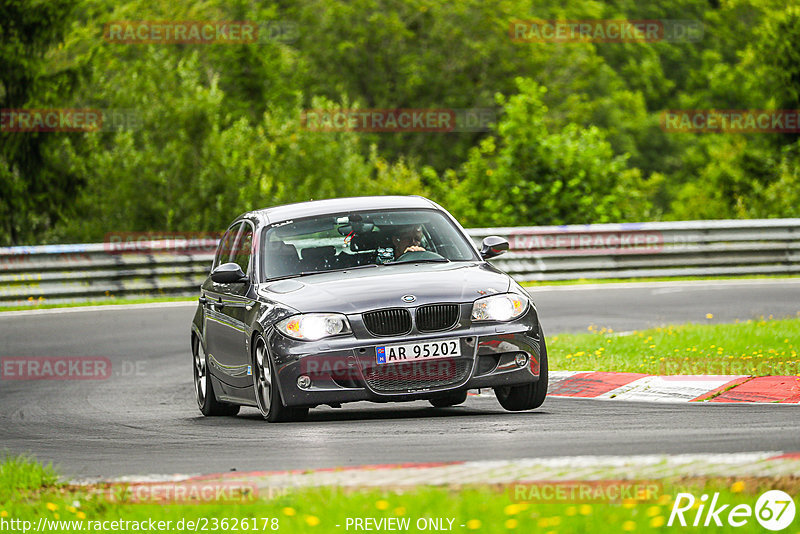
left=0, top=280, right=800, bottom=478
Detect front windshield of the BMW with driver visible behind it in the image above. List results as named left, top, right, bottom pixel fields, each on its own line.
left=261, top=210, right=478, bottom=279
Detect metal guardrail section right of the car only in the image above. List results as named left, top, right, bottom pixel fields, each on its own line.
left=470, top=219, right=800, bottom=281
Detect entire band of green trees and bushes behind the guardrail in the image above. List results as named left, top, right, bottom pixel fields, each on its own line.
left=0, top=0, right=800, bottom=244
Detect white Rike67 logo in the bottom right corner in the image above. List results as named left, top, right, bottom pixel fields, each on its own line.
left=667, top=490, right=795, bottom=530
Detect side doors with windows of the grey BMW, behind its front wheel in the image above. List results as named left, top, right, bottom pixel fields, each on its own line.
left=202, top=222, right=246, bottom=385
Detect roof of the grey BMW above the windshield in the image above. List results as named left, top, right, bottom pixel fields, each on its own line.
left=239, top=195, right=439, bottom=224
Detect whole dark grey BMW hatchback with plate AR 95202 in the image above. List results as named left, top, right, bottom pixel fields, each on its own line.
left=191, top=196, right=547, bottom=422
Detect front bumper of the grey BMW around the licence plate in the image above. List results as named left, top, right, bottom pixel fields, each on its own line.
left=267, top=307, right=542, bottom=406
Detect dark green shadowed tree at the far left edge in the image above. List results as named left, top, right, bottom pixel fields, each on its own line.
left=0, top=0, right=82, bottom=243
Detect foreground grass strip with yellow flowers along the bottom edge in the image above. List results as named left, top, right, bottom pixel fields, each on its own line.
left=0, top=458, right=798, bottom=534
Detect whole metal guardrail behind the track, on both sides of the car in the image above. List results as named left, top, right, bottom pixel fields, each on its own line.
left=0, top=219, right=800, bottom=306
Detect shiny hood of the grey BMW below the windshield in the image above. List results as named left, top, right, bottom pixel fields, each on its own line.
left=258, top=262, right=511, bottom=314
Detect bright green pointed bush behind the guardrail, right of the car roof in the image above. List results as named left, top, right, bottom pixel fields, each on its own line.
left=448, top=79, right=642, bottom=226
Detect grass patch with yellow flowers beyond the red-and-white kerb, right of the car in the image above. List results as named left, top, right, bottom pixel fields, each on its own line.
left=547, top=319, right=800, bottom=376
